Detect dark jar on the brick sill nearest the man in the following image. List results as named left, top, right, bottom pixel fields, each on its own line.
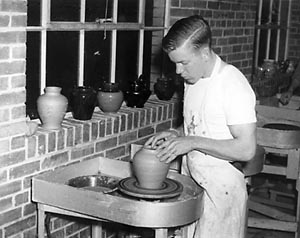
left=154, top=78, right=175, bottom=101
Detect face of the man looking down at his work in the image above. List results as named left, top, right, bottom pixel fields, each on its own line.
left=169, top=44, right=205, bottom=84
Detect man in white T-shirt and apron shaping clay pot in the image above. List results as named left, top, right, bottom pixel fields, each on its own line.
left=145, top=15, right=256, bottom=238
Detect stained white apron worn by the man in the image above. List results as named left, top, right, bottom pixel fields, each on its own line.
left=182, top=57, right=247, bottom=238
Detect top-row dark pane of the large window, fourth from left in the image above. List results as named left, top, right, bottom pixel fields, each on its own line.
left=118, top=0, right=139, bottom=22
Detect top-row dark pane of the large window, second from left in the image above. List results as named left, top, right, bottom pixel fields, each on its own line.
left=51, top=0, right=80, bottom=21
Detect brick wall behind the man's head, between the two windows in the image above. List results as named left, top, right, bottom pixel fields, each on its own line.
left=171, top=0, right=256, bottom=78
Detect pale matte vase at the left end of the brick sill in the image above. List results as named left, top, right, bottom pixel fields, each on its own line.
left=37, top=87, right=68, bottom=130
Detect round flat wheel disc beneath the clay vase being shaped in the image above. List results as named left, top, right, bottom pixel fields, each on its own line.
left=119, top=177, right=183, bottom=199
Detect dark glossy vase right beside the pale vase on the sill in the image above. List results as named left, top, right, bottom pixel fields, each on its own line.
left=69, top=86, right=97, bottom=120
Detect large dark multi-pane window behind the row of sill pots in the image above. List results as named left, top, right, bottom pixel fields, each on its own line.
left=26, top=0, right=170, bottom=118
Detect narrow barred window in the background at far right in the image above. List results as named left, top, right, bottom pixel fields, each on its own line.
left=253, top=0, right=291, bottom=67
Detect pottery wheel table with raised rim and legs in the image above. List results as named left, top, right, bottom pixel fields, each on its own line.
left=32, top=157, right=203, bottom=238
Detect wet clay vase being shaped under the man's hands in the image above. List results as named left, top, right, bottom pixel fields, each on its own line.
left=132, top=147, right=170, bottom=189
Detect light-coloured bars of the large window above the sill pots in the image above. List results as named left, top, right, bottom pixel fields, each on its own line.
left=26, top=0, right=171, bottom=94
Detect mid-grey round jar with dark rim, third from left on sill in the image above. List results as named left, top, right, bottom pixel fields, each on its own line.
left=97, top=83, right=124, bottom=112
